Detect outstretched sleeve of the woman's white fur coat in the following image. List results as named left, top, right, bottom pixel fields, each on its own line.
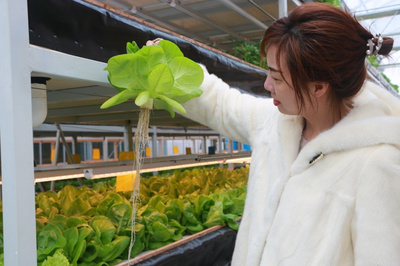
left=184, top=66, right=277, bottom=147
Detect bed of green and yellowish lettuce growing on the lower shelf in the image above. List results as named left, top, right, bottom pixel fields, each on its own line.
left=1, top=168, right=248, bottom=266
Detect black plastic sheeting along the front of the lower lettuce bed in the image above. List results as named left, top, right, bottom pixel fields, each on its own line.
left=134, top=227, right=237, bottom=266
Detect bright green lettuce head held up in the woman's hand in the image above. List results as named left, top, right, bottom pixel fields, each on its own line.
left=101, top=40, right=203, bottom=117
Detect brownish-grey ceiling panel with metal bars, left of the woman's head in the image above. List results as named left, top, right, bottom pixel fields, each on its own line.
left=94, top=0, right=301, bottom=51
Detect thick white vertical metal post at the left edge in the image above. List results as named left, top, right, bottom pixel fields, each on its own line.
left=0, top=0, right=37, bottom=266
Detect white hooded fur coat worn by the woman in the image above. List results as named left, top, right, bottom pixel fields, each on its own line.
left=185, top=67, right=400, bottom=266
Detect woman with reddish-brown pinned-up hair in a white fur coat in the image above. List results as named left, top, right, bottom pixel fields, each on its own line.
left=150, top=3, right=400, bottom=266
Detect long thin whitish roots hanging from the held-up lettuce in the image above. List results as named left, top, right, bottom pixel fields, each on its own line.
left=128, top=107, right=151, bottom=265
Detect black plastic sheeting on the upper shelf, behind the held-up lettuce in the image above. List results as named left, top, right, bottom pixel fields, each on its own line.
left=28, top=0, right=268, bottom=96
